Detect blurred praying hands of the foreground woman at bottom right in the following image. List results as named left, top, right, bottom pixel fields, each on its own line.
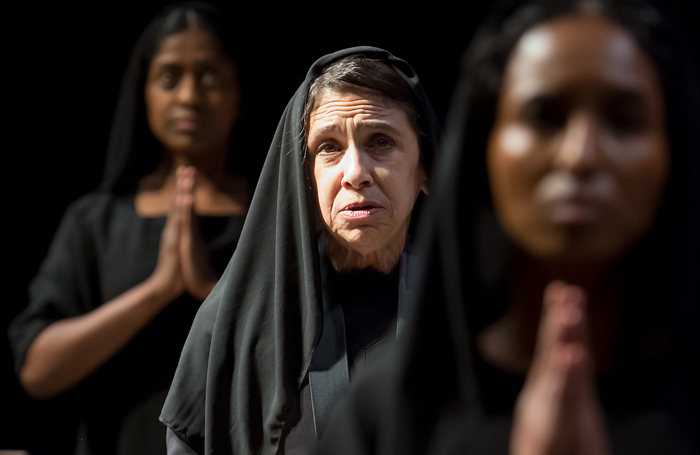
left=510, top=281, right=610, bottom=455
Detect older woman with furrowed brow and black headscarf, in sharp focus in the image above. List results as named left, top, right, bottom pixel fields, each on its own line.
left=161, top=48, right=438, bottom=454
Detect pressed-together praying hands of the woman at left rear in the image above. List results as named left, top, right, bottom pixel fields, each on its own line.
left=151, top=166, right=219, bottom=300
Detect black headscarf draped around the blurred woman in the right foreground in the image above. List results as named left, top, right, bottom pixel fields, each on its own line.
left=314, top=0, right=700, bottom=455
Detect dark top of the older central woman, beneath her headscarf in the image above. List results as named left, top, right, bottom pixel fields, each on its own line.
left=167, top=239, right=420, bottom=455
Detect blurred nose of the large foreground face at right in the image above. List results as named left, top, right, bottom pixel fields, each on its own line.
left=555, top=112, right=601, bottom=173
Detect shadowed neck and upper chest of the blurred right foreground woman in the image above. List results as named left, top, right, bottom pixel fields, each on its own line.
left=478, top=253, right=623, bottom=374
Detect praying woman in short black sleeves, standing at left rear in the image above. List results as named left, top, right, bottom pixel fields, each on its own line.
left=9, top=4, right=255, bottom=455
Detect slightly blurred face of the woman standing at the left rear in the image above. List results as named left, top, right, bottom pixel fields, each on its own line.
left=145, top=29, right=239, bottom=157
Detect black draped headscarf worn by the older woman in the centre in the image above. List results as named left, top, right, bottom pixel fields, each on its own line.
left=161, top=47, right=439, bottom=454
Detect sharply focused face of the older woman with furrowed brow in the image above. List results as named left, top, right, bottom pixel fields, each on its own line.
left=308, top=91, right=425, bottom=262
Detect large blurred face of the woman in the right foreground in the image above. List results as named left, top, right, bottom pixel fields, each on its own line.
left=487, top=17, right=669, bottom=262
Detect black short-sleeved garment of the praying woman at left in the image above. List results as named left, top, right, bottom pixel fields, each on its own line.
left=9, top=193, right=243, bottom=455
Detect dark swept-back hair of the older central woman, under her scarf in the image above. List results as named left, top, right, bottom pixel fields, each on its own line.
left=303, top=55, right=432, bottom=173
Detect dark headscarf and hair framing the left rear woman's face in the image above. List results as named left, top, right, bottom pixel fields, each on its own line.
left=101, top=2, right=259, bottom=194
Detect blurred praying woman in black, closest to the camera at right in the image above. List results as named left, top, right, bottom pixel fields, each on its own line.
left=316, top=0, right=700, bottom=455
